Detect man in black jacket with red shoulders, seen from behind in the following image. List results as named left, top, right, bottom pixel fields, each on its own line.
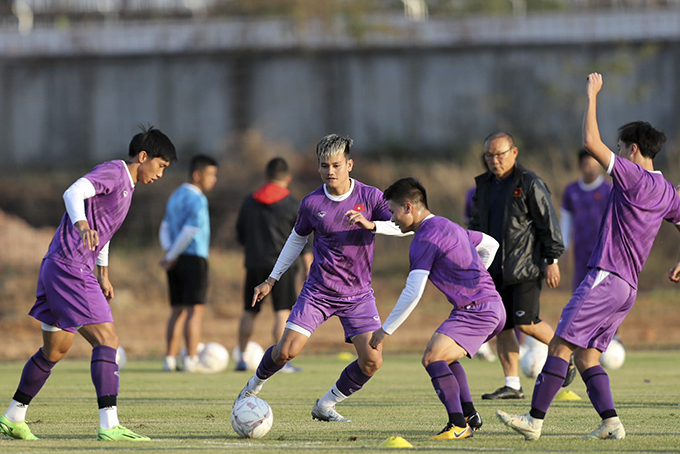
left=235, top=158, right=313, bottom=372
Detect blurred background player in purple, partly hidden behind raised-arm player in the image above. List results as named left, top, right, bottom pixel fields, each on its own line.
left=560, top=149, right=612, bottom=291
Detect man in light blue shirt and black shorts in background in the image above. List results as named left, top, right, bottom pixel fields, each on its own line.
left=158, top=155, right=217, bottom=372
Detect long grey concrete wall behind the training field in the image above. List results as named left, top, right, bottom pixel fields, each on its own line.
left=0, top=10, right=680, bottom=165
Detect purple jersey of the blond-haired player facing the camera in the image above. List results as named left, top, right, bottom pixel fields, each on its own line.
left=294, top=180, right=392, bottom=297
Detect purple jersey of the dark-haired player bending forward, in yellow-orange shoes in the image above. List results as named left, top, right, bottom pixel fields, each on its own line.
left=409, top=216, right=501, bottom=309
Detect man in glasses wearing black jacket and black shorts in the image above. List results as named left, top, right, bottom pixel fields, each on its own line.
left=469, top=132, right=576, bottom=399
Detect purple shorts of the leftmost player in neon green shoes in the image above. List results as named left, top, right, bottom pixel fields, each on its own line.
left=29, top=259, right=113, bottom=333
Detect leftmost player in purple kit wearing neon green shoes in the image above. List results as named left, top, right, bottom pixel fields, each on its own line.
left=0, top=127, right=177, bottom=441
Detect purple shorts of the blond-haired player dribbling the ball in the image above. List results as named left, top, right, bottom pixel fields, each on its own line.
left=288, top=286, right=382, bottom=343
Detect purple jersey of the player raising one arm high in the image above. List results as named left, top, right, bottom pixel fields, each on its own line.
left=588, top=153, right=680, bottom=289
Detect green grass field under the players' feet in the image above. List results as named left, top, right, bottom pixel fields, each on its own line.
left=0, top=352, right=680, bottom=453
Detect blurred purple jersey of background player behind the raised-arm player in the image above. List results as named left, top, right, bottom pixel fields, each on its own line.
left=562, top=177, right=612, bottom=288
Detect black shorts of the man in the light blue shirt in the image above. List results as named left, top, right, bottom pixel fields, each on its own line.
left=168, top=254, right=208, bottom=306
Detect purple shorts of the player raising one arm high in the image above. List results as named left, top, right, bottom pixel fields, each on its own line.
left=555, top=268, right=637, bottom=352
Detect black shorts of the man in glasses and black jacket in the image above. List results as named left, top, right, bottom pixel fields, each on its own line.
left=491, top=275, right=543, bottom=330
